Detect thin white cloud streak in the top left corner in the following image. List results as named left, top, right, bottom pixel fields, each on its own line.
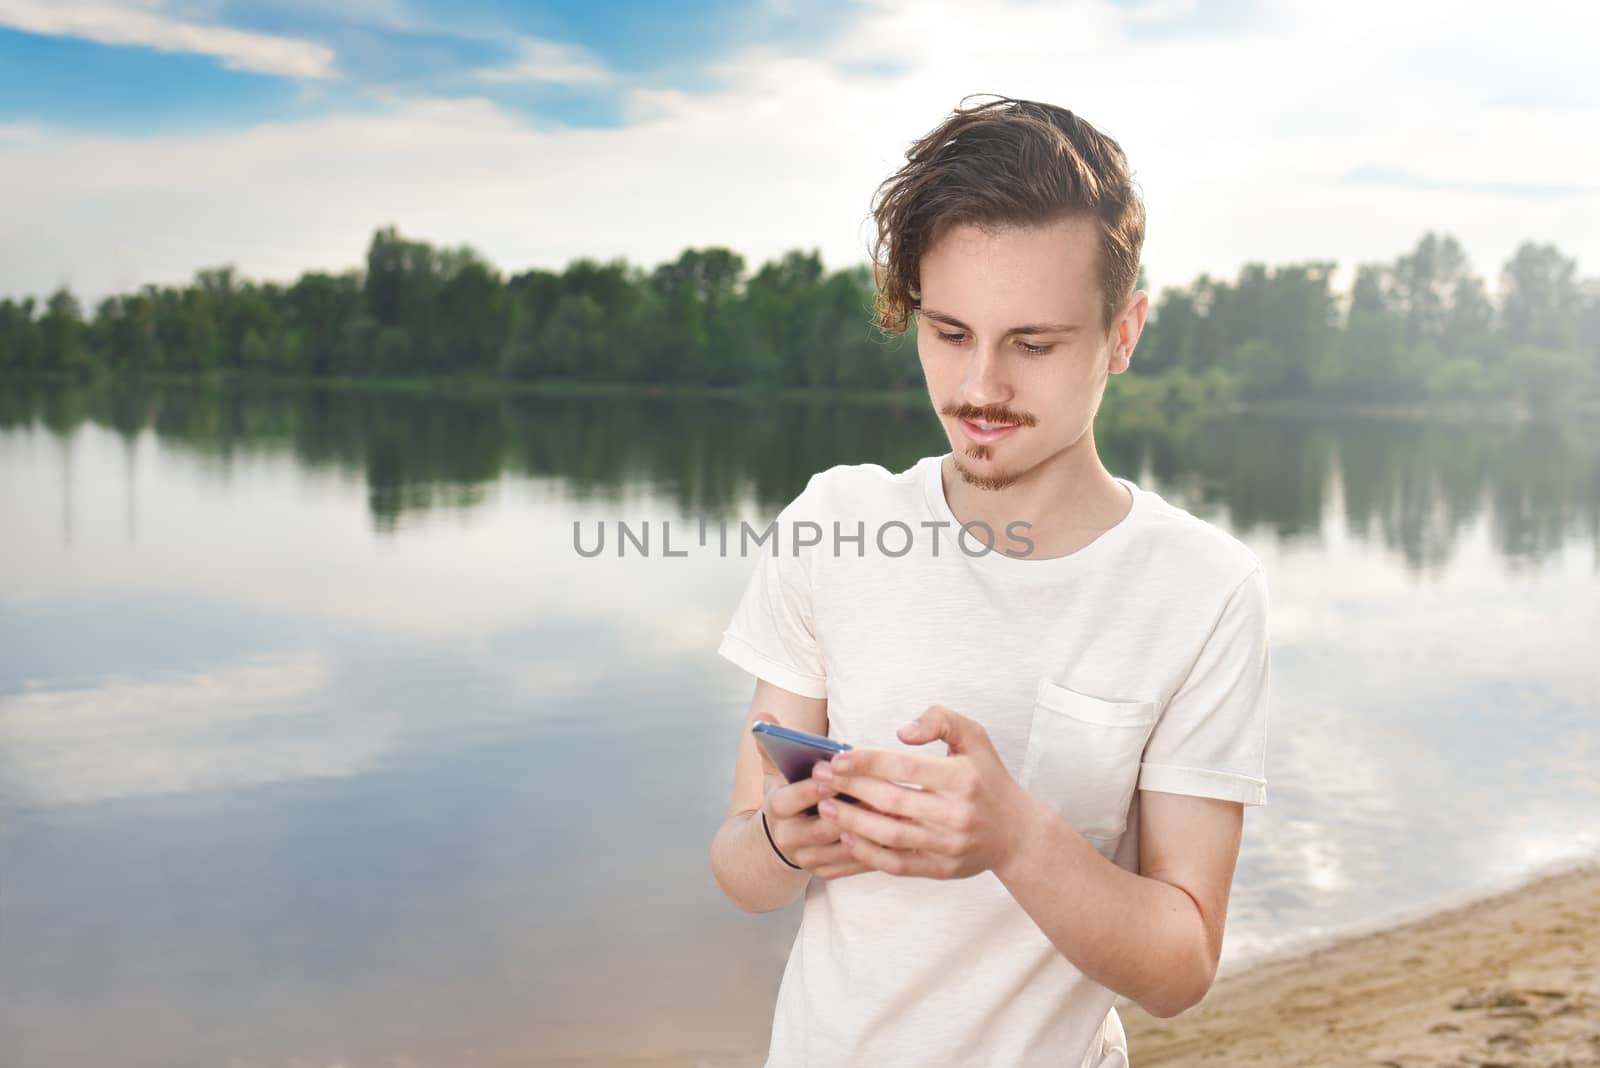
left=0, top=0, right=334, bottom=78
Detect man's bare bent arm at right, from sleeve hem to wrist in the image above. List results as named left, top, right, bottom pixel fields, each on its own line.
left=994, top=790, right=1245, bottom=1017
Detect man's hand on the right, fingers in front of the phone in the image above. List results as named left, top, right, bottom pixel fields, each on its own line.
left=811, top=705, right=1029, bottom=879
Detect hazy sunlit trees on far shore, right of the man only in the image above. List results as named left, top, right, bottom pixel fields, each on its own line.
left=1134, top=233, right=1600, bottom=411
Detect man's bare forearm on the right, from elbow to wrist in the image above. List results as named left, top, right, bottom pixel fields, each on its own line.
left=992, top=795, right=1213, bottom=1017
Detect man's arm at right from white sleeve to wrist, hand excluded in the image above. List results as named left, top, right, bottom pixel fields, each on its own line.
left=995, top=563, right=1267, bottom=1017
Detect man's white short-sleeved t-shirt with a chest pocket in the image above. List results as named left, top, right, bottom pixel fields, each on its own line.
left=718, top=452, right=1267, bottom=1068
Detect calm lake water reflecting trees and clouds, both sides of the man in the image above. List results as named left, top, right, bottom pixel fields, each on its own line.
left=0, top=384, right=1600, bottom=1068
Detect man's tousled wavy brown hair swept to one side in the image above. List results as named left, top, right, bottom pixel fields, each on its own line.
left=872, top=93, right=1144, bottom=333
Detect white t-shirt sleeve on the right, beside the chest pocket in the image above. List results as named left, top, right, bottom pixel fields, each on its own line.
left=1139, top=566, right=1267, bottom=804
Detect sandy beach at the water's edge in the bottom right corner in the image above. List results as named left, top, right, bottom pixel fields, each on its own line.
left=1118, top=860, right=1600, bottom=1068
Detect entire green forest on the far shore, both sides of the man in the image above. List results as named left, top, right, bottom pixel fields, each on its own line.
left=0, top=227, right=1600, bottom=412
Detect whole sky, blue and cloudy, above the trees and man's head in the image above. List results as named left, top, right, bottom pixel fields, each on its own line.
left=0, top=0, right=1600, bottom=302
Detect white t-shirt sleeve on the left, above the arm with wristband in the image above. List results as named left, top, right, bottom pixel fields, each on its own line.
left=717, top=475, right=827, bottom=697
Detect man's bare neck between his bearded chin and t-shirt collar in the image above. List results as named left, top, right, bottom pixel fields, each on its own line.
left=941, top=433, right=1133, bottom=560
